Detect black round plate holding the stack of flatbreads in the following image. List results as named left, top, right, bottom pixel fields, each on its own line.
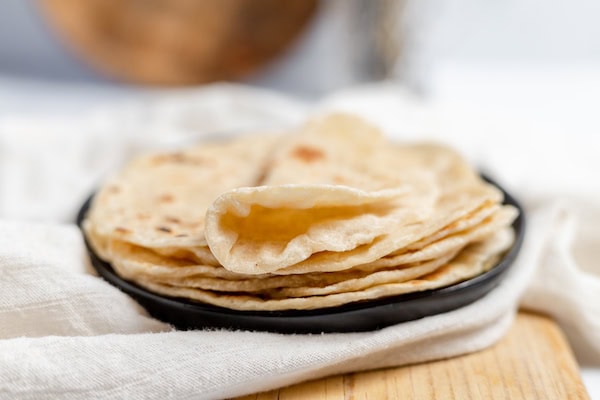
left=77, top=179, right=525, bottom=333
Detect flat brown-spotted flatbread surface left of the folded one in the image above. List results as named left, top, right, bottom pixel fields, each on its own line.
left=87, top=135, right=278, bottom=249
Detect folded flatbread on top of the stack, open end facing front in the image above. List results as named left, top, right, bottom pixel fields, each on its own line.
left=205, top=115, right=502, bottom=274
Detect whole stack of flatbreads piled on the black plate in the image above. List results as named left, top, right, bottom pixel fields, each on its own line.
left=84, top=114, right=517, bottom=311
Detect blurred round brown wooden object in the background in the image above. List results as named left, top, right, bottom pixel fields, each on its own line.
left=39, top=0, right=317, bottom=85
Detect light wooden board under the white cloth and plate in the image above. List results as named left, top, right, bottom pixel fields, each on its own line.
left=240, top=312, right=589, bottom=400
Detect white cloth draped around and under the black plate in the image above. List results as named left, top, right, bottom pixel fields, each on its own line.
left=0, top=86, right=600, bottom=399
